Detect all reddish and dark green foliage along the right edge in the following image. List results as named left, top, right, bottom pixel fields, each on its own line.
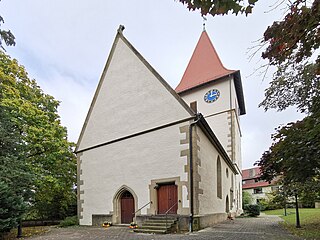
left=256, top=0, right=320, bottom=206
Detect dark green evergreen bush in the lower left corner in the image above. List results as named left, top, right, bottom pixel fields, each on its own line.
left=0, top=180, right=25, bottom=236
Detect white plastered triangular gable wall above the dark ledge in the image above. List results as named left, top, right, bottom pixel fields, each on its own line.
left=78, top=38, right=190, bottom=150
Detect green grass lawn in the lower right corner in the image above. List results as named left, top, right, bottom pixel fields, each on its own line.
left=264, top=208, right=320, bottom=239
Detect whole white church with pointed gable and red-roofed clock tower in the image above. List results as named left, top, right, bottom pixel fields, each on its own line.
left=76, top=26, right=246, bottom=230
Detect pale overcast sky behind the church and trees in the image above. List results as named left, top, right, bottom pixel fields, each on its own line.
left=0, top=0, right=301, bottom=168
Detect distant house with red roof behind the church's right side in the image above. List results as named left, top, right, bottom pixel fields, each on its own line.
left=242, top=167, right=279, bottom=204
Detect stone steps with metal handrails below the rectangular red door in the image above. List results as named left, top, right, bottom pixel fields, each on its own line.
left=133, top=215, right=177, bottom=234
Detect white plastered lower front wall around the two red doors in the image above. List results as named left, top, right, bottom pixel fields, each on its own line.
left=80, top=123, right=188, bottom=225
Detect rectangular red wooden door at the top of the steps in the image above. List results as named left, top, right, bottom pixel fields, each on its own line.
left=158, top=184, right=178, bottom=214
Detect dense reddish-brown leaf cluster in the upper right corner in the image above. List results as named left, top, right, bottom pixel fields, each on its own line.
left=262, top=0, right=320, bottom=75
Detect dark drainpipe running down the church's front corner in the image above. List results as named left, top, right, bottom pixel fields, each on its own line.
left=189, top=115, right=200, bottom=232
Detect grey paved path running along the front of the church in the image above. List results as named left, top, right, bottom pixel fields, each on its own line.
left=28, top=215, right=300, bottom=240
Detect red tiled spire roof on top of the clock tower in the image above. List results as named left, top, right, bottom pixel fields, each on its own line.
left=175, top=31, right=237, bottom=93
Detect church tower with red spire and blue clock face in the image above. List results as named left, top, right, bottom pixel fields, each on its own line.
left=175, top=30, right=246, bottom=212
